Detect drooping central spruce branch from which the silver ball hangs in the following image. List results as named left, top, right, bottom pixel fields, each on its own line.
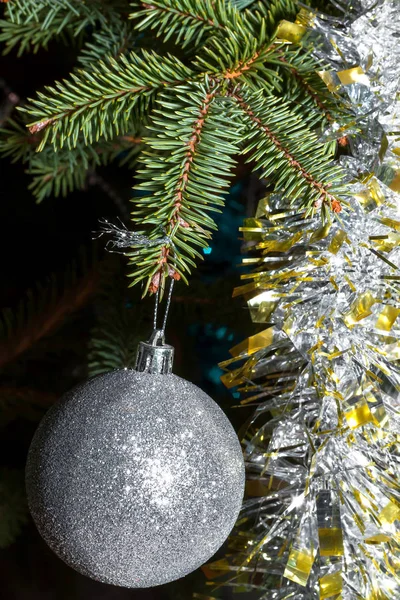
left=130, top=77, right=240, bottom=293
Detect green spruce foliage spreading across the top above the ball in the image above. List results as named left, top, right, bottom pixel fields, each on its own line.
left=0, top=0, right=346, bottom=293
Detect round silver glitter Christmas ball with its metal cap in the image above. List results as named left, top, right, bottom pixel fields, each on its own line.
left=26, top=332, right=244, bottom=588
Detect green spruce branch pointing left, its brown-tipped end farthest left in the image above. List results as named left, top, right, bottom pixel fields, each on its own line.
left=20, top=50, right=193, bottom=151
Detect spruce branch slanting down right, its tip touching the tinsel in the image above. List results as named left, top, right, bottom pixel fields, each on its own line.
left=230, top=88, right=347, bottom=220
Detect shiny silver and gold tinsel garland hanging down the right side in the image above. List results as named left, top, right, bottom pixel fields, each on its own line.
left=216, top=0, right=400, bottom=600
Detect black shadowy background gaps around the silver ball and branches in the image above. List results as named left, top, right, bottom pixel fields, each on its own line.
left=0, top=25, right=259, bottom=600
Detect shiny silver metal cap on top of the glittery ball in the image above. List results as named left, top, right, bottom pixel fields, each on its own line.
left=135, top=329, right=174, bottom=375
